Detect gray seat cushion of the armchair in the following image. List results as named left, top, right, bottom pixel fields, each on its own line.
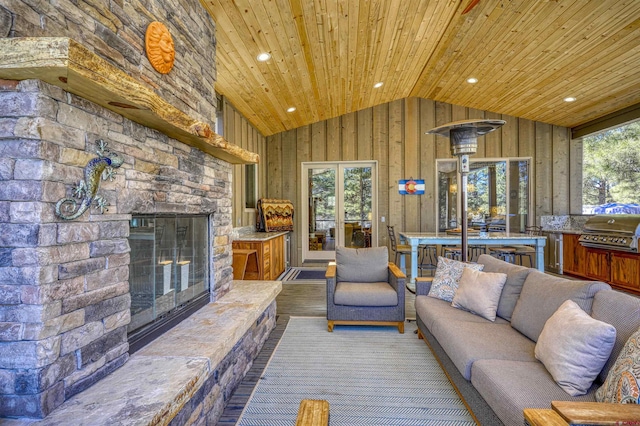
left=333, top=282, right=398, bottom=306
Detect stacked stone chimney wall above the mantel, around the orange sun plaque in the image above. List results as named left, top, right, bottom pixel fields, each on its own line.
left=0, top=0, right=216, bottom=128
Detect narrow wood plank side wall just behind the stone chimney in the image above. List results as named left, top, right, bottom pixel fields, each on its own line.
left=222, top=98, right=268, bottom=227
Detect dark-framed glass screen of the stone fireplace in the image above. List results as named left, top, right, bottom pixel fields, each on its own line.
left=128, top=215, right=209, bottom=341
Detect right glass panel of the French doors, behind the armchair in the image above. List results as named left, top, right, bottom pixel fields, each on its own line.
left=344, top=167, right=373, bottom=247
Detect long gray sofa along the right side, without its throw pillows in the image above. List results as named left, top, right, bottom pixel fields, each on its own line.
left=415, top=255, right=640, bottom=425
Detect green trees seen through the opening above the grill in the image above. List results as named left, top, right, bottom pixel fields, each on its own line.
left=582, top=122, right=640, bottom=205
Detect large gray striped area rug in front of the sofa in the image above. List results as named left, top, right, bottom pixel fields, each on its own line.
left=237, top=317, right=475, bottom=426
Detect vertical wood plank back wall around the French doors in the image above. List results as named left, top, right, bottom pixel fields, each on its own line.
left=264, top=98, right=582, bottom=266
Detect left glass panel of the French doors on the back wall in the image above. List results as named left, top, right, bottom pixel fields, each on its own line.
left=307, top=168, right=336, bottom=251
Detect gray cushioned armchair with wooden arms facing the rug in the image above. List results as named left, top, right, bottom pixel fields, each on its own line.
left=325, top=247, right=406, bottom=333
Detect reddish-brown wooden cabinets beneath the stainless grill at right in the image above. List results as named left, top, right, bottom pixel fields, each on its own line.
left=562, top=234, right=640, bottom=293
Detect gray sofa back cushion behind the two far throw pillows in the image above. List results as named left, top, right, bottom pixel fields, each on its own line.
left=478, top=254, right=534, bottom=321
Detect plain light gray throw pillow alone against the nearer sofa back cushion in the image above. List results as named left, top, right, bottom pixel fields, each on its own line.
left=535, top=300, right=616, bottom=396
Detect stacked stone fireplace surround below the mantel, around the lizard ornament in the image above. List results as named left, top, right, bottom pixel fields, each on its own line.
left=0, top=80, right=233, bottom=417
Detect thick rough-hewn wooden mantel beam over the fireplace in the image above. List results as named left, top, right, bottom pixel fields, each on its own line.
left=0, top=37, right=259, bottom=164
